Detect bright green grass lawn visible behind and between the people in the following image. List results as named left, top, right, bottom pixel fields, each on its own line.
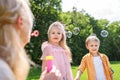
left=27, top=61, right=120, bottom=80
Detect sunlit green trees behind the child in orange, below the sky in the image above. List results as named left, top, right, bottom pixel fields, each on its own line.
left=60, top=9, right=120, bottom=65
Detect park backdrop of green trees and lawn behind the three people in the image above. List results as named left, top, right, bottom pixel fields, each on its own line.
left=25, top=0, right=120, bottom=80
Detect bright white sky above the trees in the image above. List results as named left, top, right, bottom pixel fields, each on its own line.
left=62, top=0, right=120, bottom=22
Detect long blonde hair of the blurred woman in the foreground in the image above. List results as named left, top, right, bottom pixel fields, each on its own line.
left=0, top=0, right=33, bottom=80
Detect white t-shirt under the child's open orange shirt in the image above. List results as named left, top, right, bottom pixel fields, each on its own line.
left=93, top=56, right=106, bottom=80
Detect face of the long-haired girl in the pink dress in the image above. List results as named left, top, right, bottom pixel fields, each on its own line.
left=49, top=27, right=62, bottom=44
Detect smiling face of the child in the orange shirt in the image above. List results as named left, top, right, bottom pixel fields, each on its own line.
left=86, top=41, right=99, bottom=55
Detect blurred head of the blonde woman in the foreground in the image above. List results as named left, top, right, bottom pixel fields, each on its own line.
left=0, top=0, right=33, bottom=46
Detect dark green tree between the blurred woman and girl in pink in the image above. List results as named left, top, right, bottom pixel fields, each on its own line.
left=25, top=0, right=61, bottom=64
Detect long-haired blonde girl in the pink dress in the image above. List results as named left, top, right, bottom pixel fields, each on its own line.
left=40, top=22, right=73, bottom=80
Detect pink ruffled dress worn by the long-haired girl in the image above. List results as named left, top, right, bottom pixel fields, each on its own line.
left=41, top=43, right=73, bottom=80
